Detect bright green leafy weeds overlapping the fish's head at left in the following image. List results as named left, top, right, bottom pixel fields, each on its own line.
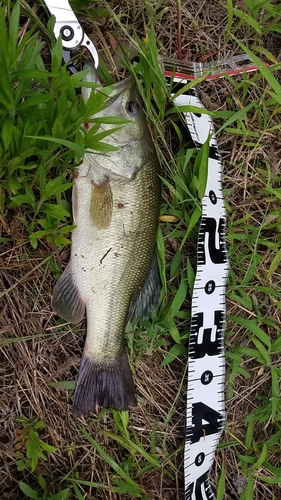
left=0, top=2, right=127, bottom=248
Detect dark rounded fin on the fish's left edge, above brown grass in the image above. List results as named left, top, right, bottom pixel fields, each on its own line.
left=52, top=262, right=85, bottom=324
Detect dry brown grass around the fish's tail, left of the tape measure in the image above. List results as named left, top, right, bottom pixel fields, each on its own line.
left=0, top=240, right=185, bottom=500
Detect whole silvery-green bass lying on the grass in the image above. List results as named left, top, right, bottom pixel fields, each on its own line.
left=52, top=64, right=161, bottom=417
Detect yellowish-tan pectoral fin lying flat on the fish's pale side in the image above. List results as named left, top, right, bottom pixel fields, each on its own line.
left=90, top=182, right=112, bottom=229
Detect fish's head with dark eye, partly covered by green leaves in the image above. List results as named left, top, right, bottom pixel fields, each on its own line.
left=82, top=63, right=155, bottom=181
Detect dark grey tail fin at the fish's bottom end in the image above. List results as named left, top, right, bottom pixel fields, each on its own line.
left=73, top=350, right=137, bottom=417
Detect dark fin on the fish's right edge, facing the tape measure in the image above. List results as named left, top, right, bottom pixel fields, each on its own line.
left=128, top=253, right=161, bottom=323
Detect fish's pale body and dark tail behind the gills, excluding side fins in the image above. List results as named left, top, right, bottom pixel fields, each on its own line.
left=68, top=158, right=158, bottom=415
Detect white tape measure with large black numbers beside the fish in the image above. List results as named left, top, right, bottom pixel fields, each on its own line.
left=166, top=74, right=229, bottom=500
